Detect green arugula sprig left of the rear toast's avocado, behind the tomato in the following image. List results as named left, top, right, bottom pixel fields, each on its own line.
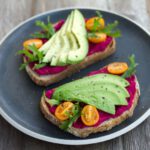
left=31, top=17, right=55, bottom=39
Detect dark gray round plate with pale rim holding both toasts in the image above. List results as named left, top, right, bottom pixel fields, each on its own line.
left=0, top=8, right=150, bottom=145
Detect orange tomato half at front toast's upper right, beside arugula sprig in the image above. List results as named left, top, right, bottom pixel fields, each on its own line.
left=107, top=62, right=128, bottom=74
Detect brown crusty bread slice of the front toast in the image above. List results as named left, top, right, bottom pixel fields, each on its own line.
left=40, top=75, right=140, bottom=138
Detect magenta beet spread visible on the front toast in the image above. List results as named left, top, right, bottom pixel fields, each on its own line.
left=46, top=68, right=136, bottom=128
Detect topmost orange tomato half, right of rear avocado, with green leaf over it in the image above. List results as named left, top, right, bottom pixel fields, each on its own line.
left=86, top=17, right=105, bottom=31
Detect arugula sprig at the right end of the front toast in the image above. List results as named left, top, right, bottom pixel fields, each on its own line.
left=122, top=54, right=138, bottom=78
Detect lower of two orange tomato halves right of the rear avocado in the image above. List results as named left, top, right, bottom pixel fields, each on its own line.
left=88, top=33, right=107, bottom=44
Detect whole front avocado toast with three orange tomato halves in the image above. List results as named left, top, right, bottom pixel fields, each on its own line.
left=40, top=55, right=140, bottom=137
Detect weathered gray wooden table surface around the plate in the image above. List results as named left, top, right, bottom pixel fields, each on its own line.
left=0, top=0, right=150, bottom=150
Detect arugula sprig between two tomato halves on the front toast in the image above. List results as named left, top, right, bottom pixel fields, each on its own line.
left=59, top=103, right=81, bottom=130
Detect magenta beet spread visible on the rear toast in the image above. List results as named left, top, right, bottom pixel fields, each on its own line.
left=29, top=20, right=112, bottom=75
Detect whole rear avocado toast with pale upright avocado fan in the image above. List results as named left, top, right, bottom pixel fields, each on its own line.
left=18, top=10, right=120, bottom=86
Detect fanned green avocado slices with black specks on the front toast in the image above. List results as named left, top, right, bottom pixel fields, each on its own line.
left=52, top=74, right=130, bottom=114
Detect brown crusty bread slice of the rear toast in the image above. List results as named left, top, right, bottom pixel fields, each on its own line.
left=23, top=38, right=116, bottom=86
